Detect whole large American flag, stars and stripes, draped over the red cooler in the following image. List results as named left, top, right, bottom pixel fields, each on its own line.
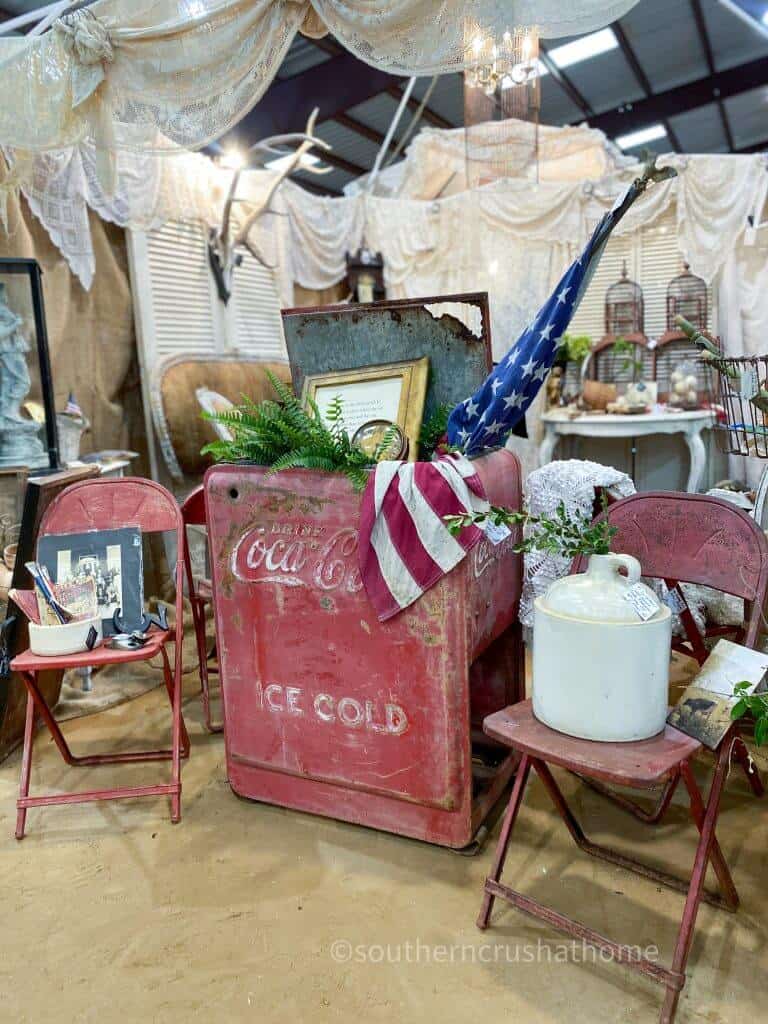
left=358, top=171, right=674, bottom=621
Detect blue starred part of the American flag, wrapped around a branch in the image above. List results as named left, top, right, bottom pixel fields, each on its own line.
left=447, top=161, right=676, bottom=455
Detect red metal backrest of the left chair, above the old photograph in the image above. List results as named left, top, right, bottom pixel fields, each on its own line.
left=40, top=476, right=183, bottom=537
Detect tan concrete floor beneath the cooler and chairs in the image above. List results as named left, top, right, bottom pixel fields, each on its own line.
left=0, top=663, right=768, bottom=1024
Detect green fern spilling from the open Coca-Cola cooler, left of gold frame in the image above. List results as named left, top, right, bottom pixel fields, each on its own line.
left=202, top=371, right=393, bottom=490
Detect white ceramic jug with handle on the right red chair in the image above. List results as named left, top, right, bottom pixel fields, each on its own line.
left=534, top=554, right=672, bottom=742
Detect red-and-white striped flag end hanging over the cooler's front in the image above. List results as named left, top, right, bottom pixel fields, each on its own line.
left=358, top=453, right=488, bottom=622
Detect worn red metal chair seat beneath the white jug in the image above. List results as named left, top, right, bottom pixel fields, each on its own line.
left=482, top=700, right=701, bottom=790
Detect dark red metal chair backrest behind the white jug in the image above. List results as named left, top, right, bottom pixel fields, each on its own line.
left=573, top=492, right=768, bottom=646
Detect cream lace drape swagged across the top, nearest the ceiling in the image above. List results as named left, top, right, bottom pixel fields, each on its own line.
left=0, top=0, right=637, bottom=161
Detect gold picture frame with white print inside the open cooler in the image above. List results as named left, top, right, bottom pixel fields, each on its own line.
left=301, top=355, right=429, bottom=462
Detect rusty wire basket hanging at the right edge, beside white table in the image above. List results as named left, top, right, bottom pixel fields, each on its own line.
left=710, top=355, right=768, bottom=459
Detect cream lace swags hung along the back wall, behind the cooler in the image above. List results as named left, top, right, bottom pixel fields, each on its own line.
left=7, top=128, right=768, bottom=315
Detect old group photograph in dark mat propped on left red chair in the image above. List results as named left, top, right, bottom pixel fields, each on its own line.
left=37, top=526, right=144, bottom=636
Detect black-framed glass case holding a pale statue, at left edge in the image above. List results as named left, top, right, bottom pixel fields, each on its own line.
left=0, top=258, right=59, bottom=471
